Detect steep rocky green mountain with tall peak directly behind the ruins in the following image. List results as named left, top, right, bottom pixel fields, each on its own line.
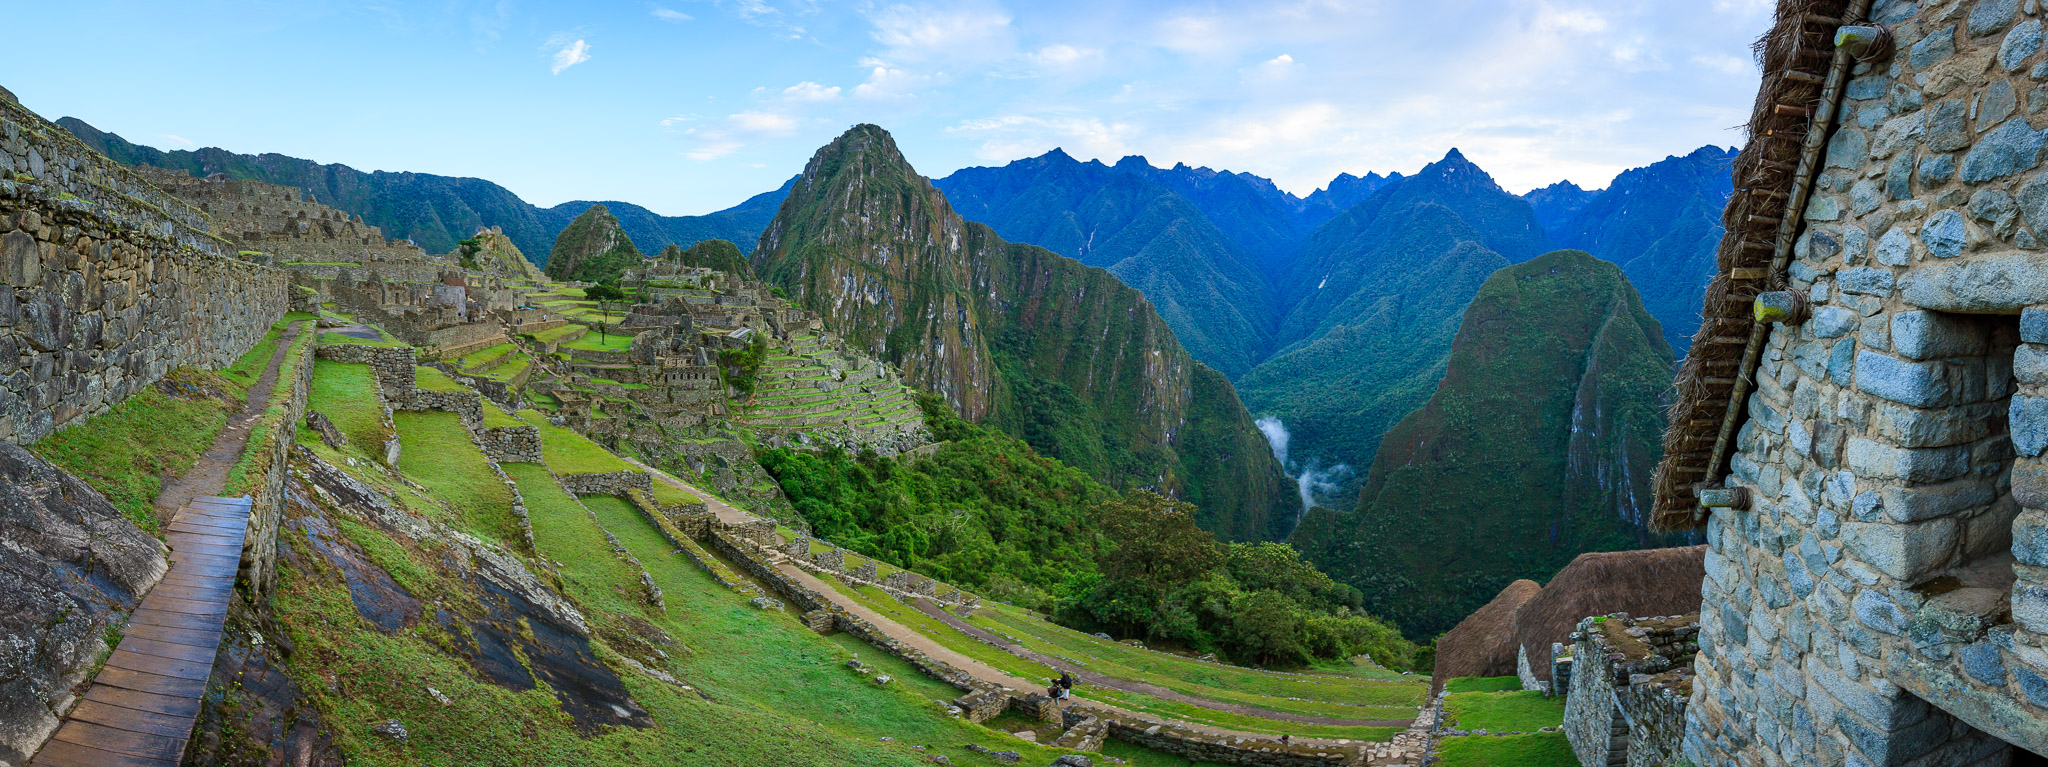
left=754, top=125, right=1294, bottom=540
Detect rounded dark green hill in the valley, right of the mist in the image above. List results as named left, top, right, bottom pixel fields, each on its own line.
left=1290, top=250, right=1671, bottom=636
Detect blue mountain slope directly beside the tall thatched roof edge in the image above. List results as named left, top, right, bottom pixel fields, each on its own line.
left=1550, top=145, right=1735, bottom=356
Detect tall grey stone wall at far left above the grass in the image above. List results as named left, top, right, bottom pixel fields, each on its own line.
left=0, top=96, right=291, bottom=444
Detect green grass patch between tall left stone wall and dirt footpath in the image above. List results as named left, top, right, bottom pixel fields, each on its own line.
left=31, top=370, right=234, bottom=532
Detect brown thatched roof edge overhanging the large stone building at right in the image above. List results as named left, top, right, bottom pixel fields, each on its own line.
left=1651, top=0, right=1870, bottom=532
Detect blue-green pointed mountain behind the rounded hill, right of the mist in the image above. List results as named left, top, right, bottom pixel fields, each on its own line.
left=1237, top=149, right=1544, bottom=503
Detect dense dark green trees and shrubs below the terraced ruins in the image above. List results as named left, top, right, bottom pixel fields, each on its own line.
left=758, top=397, right=1413, bottom=667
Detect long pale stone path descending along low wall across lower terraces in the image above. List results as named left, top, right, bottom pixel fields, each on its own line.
left=625, top=458, right=1415, bottom=765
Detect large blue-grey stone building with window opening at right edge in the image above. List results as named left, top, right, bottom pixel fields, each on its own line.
left=1659, top=0, right=2048, bottom=767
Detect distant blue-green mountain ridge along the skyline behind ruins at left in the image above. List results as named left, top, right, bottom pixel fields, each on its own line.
left=57, top=117, right=788, bottom=256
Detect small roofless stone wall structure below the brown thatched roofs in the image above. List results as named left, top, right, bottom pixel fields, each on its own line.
left=1563, top=614, right=1700, bottom=767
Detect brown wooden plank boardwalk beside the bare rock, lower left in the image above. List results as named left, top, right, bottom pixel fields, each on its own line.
left=29, top=497, right=254, bottom=767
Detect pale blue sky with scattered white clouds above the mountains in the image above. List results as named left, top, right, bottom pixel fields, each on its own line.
left=0, top=0, right=1774, bottom=215
